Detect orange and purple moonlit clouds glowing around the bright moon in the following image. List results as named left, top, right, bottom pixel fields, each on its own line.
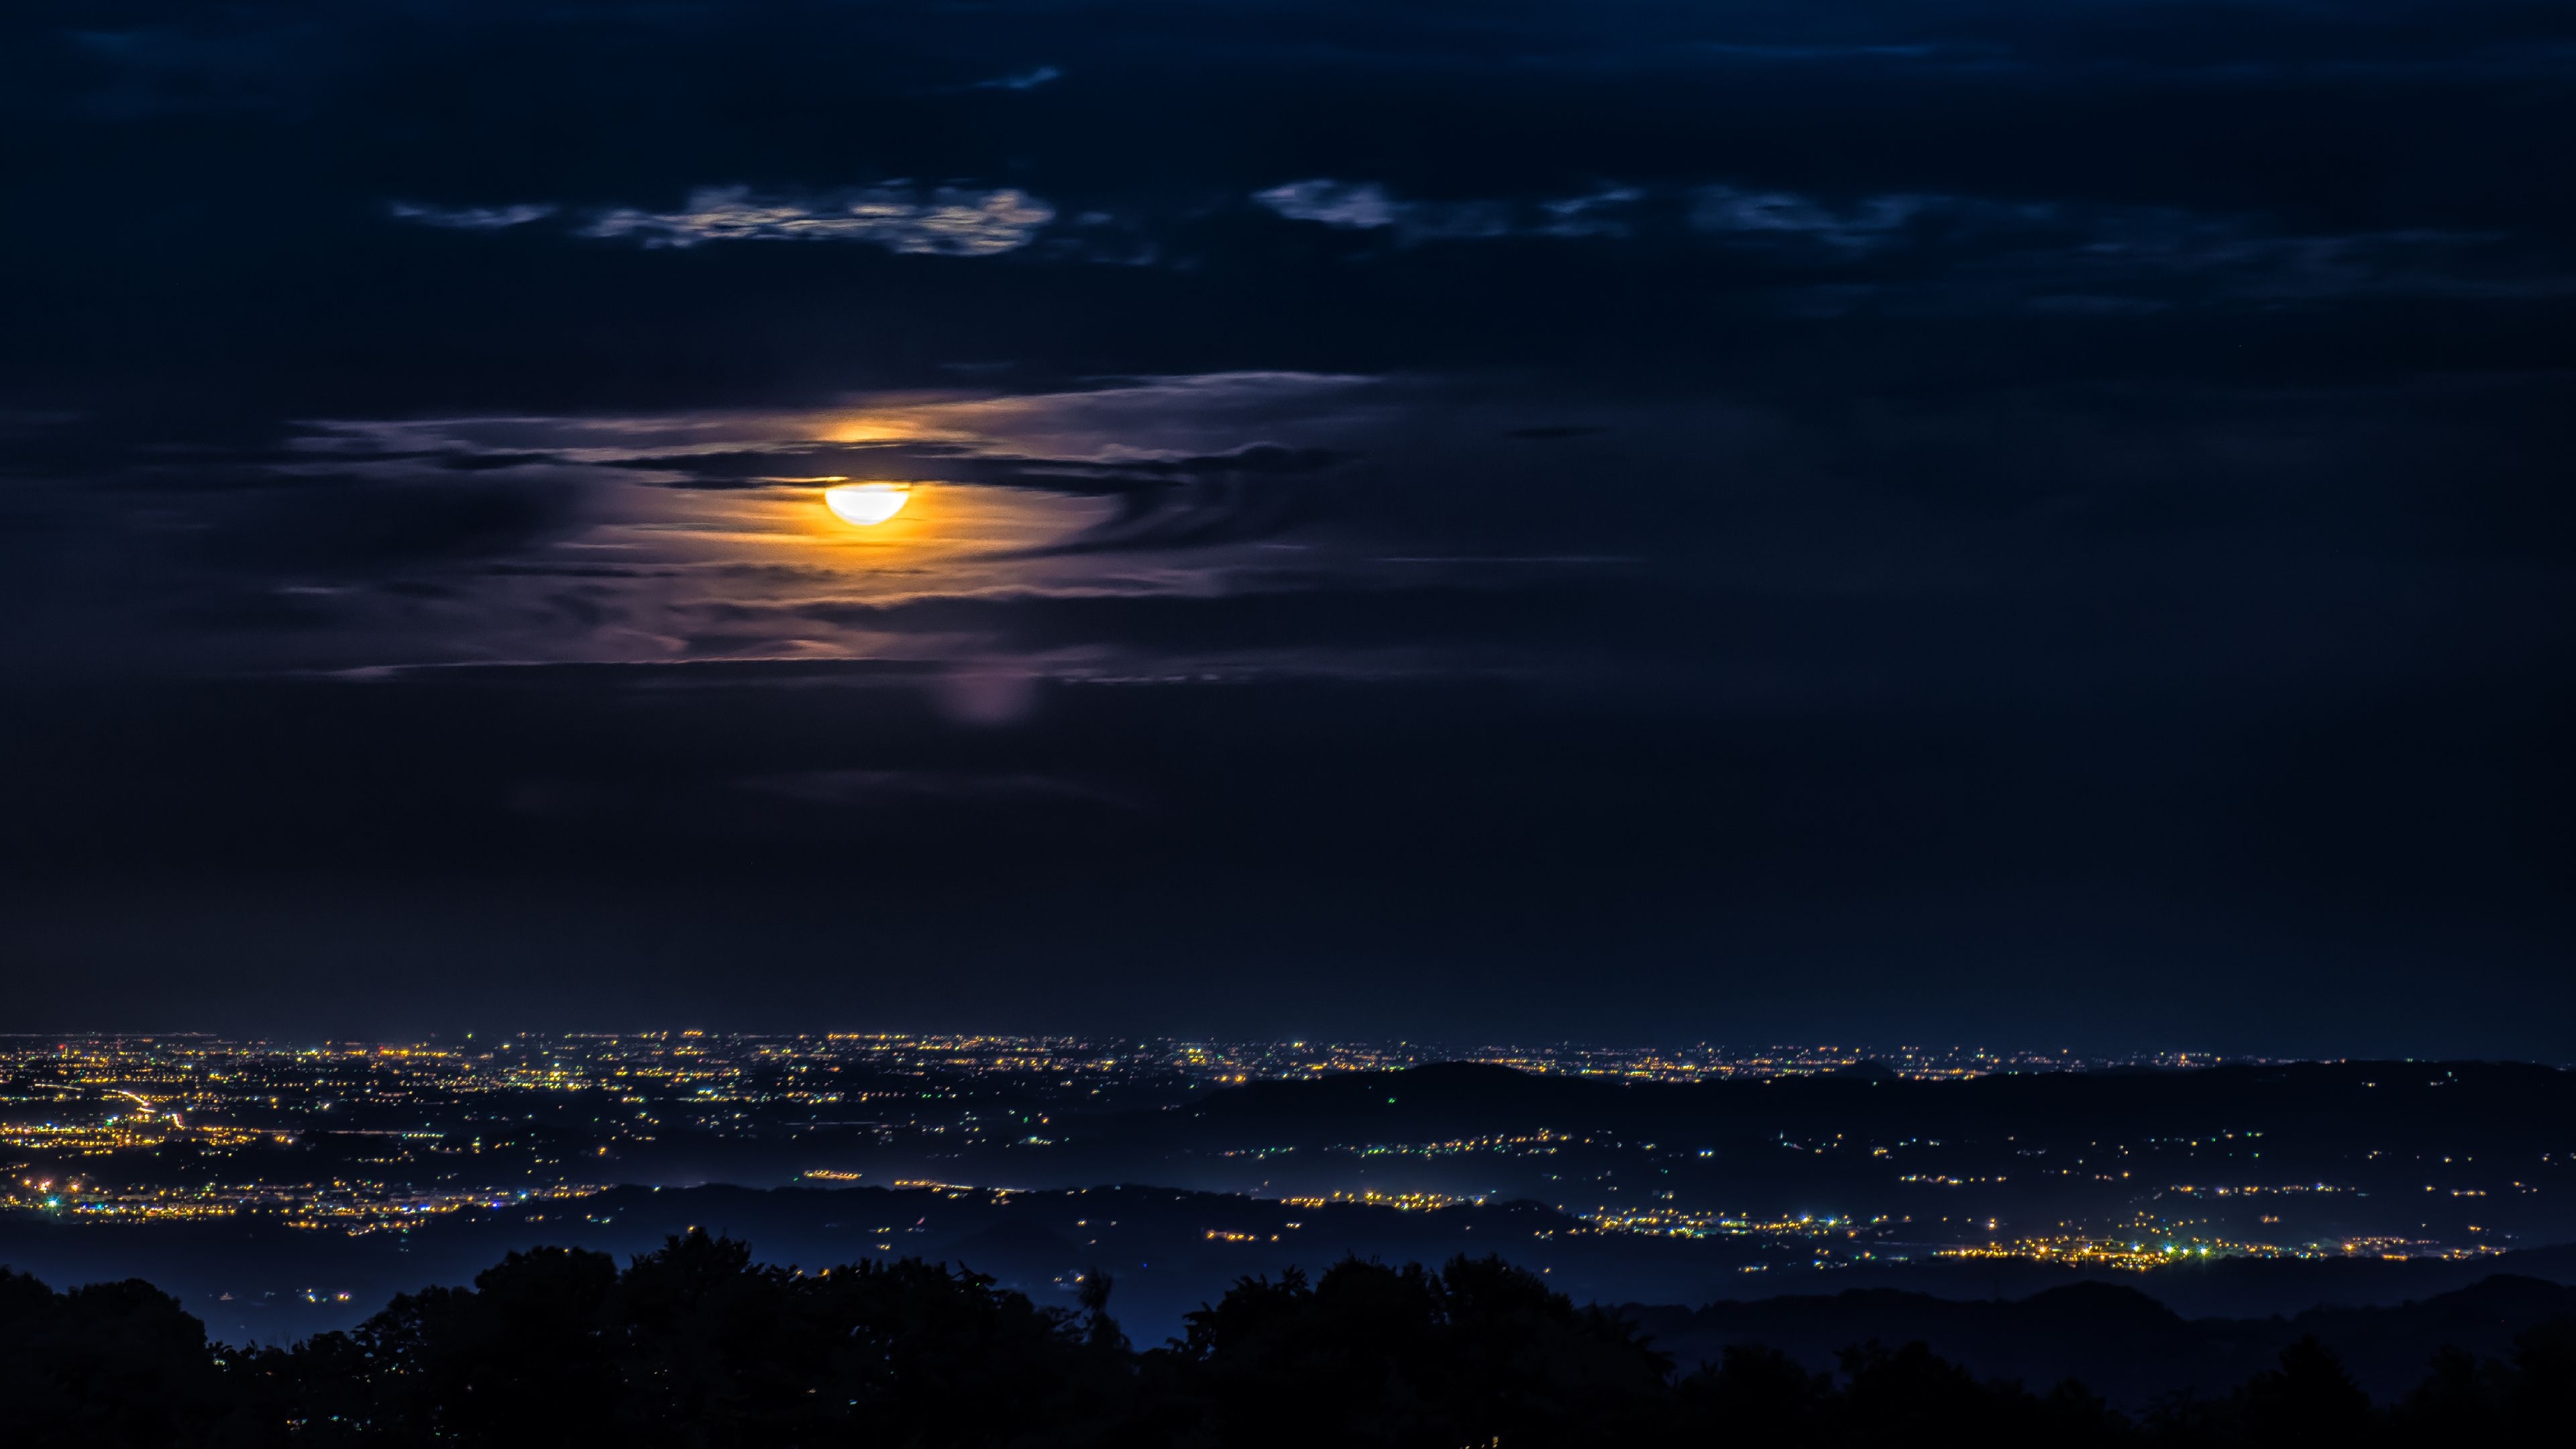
left=281, top=374, right=1381, bottom=667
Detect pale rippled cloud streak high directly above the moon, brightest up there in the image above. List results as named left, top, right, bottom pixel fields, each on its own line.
left=582, top=186, right=1056, bottom=255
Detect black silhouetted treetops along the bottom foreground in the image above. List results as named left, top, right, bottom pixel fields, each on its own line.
left=0, top=1232, right=2576, bottom=1449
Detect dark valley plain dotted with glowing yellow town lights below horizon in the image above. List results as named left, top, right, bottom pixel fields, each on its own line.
left=0, top=1031, right=2568, bottom=1271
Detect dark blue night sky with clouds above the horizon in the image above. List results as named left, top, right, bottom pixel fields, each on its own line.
left=0, top=0, right=2576, bottom=1060
